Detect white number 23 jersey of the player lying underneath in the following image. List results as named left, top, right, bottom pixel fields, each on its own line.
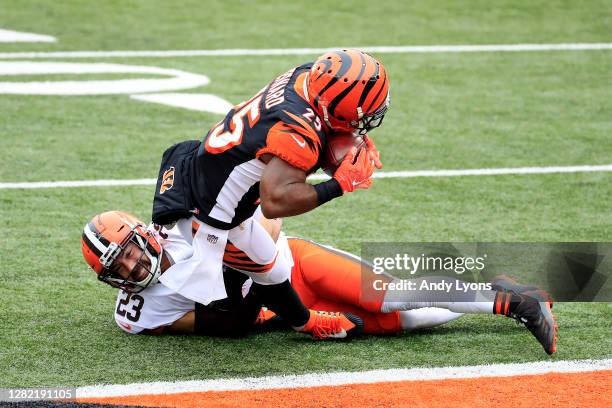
left=115, top=219, right=293, bottom=334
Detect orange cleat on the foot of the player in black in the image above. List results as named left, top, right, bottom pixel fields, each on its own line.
left=301, top=310, right=363, bottom=340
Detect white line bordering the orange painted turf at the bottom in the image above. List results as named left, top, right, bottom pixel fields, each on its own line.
left=76, top=359, right=612, bottom=398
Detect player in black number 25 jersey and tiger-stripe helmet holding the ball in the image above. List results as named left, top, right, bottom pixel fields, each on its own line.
left=153, top=50, right=389, bottom=338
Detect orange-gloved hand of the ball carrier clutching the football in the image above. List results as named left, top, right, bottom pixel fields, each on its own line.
left=334, top=147, right=374, bottom=193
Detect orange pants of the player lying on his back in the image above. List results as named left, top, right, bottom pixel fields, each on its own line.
left=289, top=238, right=401, bottom=334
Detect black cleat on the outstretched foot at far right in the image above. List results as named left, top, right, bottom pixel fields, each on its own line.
left=494, top=291, right=557, bottom=354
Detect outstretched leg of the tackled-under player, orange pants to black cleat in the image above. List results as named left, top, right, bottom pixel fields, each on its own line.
left=290, top=239, right=556, bottom=354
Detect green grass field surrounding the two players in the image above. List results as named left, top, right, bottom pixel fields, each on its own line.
left=0, top=0, right=612, bottom=387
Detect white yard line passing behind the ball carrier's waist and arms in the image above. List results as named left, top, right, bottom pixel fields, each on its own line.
left=0, top=164, right=612, bottom=190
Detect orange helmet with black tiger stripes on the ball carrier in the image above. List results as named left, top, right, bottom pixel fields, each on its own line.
left=306, top=49, right=389, bottom=134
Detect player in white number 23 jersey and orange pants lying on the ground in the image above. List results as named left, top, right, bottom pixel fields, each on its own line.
left=82, top=211, right=556, bottom=354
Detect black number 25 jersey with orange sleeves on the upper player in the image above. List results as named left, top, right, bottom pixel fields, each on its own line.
left=157, top=64, right=326, bottom=229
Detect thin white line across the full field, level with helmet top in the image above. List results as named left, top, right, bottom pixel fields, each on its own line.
left=0, top=43, right=612, bottom=58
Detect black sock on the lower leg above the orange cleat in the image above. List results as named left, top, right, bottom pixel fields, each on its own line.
left=251, top=280, right=310, bottom=327
